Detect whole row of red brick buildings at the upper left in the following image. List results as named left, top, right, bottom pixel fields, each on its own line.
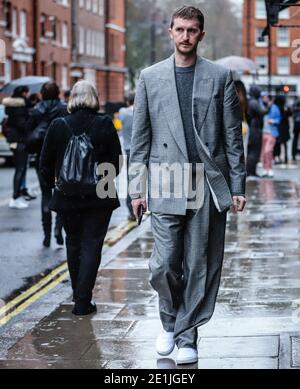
left=0, top=0, right=126, bottom=106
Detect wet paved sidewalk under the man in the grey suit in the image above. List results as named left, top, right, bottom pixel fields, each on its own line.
left=0, top=163, right=300, bottom=369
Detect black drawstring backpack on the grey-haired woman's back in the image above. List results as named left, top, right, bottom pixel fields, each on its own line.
left=56, top=119, right=99, bottom=197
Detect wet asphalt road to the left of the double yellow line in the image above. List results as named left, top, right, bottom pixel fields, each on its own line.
left=0, top=166, right=128, bottom=301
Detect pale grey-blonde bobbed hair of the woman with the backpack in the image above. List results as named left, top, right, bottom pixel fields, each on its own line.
left=68, top=80, right=100, bottom=113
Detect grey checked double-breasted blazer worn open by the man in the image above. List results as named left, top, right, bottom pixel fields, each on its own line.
left=129, top=55, right=246, bottom=215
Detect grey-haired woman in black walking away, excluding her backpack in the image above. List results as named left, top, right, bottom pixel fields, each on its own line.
left=40, top=81, right=122, bottom=315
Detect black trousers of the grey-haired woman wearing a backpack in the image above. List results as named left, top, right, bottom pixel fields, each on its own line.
left=61, top=209, right=112, bottom=306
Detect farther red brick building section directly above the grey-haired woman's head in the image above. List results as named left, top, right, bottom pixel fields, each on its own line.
left=71, top=0, right=126, bottom=106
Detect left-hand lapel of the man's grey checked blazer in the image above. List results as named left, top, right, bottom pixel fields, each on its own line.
left=159, top=55, right=188, bottom=159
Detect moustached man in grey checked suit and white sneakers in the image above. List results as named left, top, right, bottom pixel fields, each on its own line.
left=130, top=6, right=246, bottom=364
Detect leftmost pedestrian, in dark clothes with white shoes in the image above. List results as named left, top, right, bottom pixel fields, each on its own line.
left=2, top=86, right=31, bottom=209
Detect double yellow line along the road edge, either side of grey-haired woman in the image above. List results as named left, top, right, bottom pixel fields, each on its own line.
left=0, top=222, right=136, bottom=327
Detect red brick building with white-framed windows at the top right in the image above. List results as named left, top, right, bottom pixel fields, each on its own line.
left=243, top=0, right=300, bottom=94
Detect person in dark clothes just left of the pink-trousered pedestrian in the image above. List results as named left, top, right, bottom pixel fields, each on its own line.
left=247, top=85, right=269, bottom=177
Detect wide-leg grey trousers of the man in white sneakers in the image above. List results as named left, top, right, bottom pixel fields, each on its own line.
left=150, top=182, right=227, bottom=348
